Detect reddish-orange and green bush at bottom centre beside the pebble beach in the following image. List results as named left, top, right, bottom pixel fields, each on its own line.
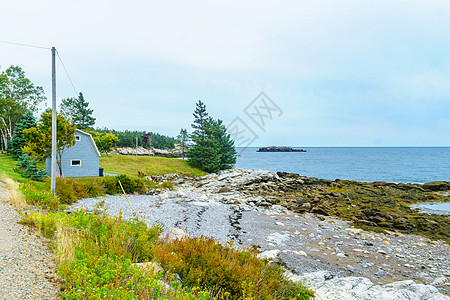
left=155, top=237, right=313, bottom=299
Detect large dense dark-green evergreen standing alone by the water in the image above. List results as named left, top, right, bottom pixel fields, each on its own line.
left=187, top=100, right=236, bottom=173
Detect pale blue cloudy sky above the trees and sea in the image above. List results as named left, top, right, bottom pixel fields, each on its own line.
left=0, top=0, right=450, bottom=147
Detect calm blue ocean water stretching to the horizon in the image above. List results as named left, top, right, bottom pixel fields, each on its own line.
left=236, top=147, right=450, bottom=183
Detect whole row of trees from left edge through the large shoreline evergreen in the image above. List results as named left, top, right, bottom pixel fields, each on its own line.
left=0, top=66, right=236, bottom=176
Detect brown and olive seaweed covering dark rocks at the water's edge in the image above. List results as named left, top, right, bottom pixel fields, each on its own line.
left=253, top=172, right=450, bottom=243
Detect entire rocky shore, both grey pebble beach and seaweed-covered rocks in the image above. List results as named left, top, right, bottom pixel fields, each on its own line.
left=77, top=169, right=450, bottom=300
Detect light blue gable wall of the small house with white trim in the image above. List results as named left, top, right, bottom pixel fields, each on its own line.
left=45, top=131, right=99, bottom=177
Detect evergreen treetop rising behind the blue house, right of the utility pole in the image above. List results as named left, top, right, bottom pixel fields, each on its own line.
left=61, top=93, right=95, bottom=130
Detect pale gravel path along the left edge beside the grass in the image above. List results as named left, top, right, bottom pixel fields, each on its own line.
left=0, top=182, right=58, bottom=300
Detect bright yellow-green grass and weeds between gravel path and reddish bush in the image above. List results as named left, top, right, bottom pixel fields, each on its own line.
left=23, top=211, right=214, bottom=300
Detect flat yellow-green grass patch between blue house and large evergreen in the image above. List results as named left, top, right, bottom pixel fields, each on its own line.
left=100, top=155, right=207, bottom=176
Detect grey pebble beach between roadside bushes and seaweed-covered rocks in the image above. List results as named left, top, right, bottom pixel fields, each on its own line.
left=74, top=169, right=450, bottom=299
